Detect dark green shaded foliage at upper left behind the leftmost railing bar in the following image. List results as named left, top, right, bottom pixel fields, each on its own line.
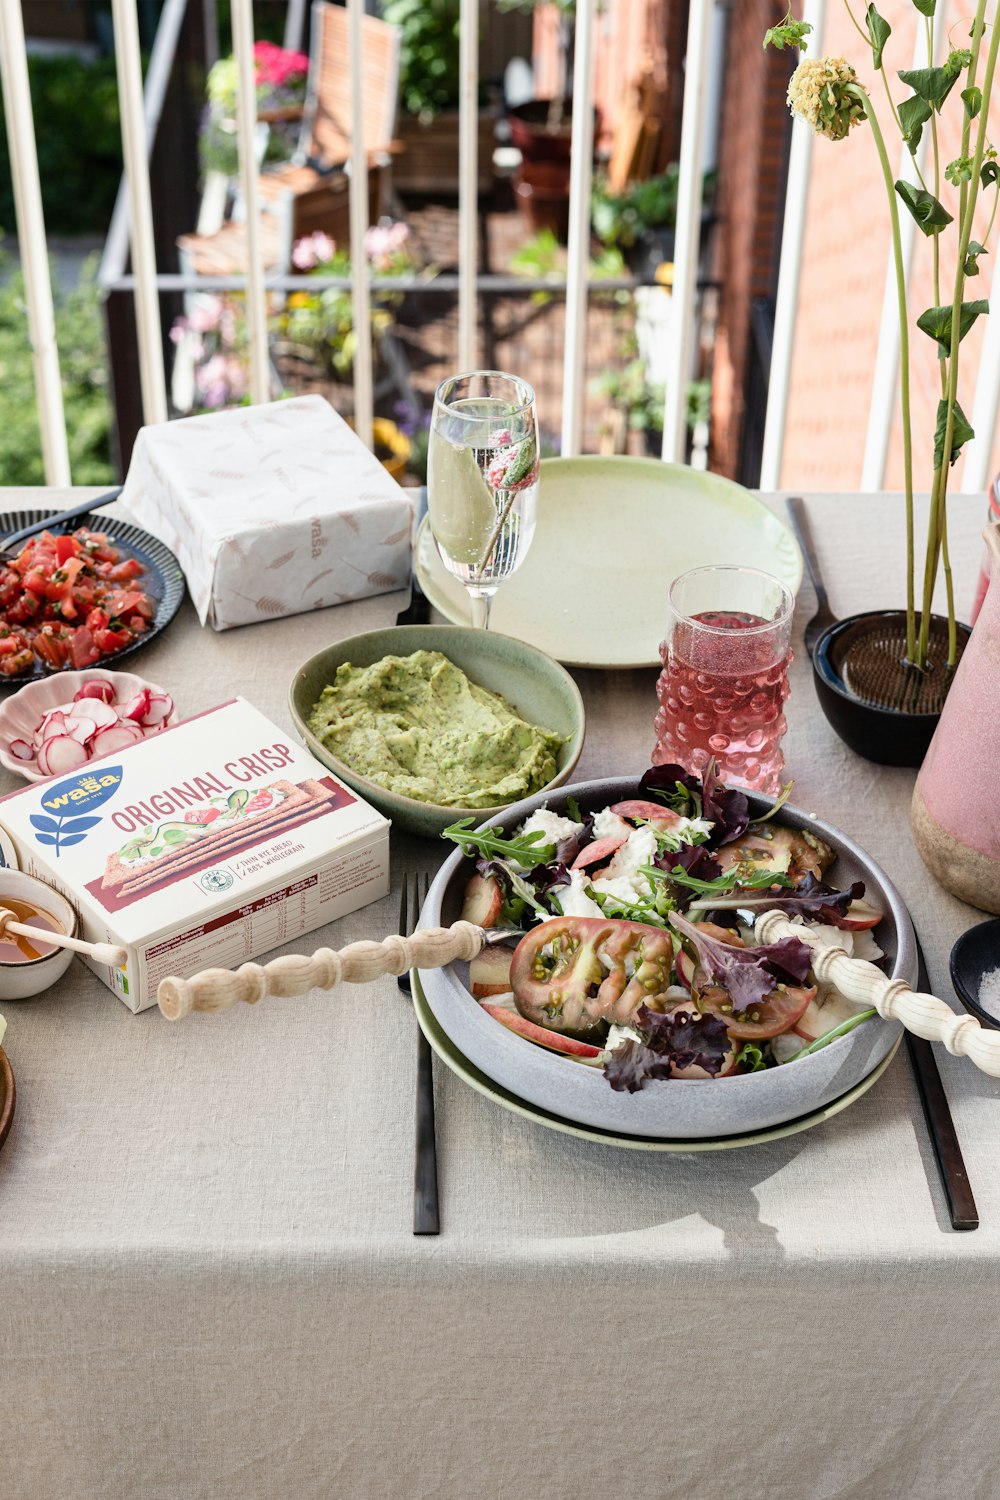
left=0, top=57, right=121, bottom=234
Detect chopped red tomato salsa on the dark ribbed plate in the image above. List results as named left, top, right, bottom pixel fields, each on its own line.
left=0, top=527, right=156, bottom=677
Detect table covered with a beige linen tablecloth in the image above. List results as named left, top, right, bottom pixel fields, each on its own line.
left=0, top=491, right=1000, bottom=1500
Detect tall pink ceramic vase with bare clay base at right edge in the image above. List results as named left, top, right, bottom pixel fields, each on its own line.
left=913, top=522, right=1000, bottom=912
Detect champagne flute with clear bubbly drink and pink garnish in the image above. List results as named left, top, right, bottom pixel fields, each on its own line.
left=427, top=371, right=538, bottom=630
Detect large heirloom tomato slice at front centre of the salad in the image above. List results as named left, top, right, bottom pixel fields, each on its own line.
left=510, top=917, right=673, bottom=1037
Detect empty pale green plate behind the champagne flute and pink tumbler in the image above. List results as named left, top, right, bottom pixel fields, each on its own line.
left=415, top=458, right=802, bottom=668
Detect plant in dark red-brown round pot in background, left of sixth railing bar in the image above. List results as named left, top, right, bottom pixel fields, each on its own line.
left=499, top=0, right=576, bottom=242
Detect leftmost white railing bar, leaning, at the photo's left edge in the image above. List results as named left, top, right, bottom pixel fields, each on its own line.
left=0, top=0, right=72, bottom=486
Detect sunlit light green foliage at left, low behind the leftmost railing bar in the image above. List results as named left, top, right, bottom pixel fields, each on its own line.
left=0, top=245, right=114, bottom=485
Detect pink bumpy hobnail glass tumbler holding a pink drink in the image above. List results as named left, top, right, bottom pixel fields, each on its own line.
left=652, top=566, right=795, bottom=794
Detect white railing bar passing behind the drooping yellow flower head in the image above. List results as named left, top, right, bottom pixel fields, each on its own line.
left=760, top=0, right=826, bottom=491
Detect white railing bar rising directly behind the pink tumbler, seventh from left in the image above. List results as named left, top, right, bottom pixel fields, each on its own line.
left=663, top=0, right=715, bottom=464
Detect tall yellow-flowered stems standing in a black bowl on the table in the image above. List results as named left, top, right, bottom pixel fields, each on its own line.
left=765, top=0, right=1000, bottom=765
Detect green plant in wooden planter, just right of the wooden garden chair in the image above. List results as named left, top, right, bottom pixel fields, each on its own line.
left=382, top=0, right=498, bottom=194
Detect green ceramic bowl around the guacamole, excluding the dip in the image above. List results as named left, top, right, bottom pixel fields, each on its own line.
left=288, top=626, right=585, bottom=839
